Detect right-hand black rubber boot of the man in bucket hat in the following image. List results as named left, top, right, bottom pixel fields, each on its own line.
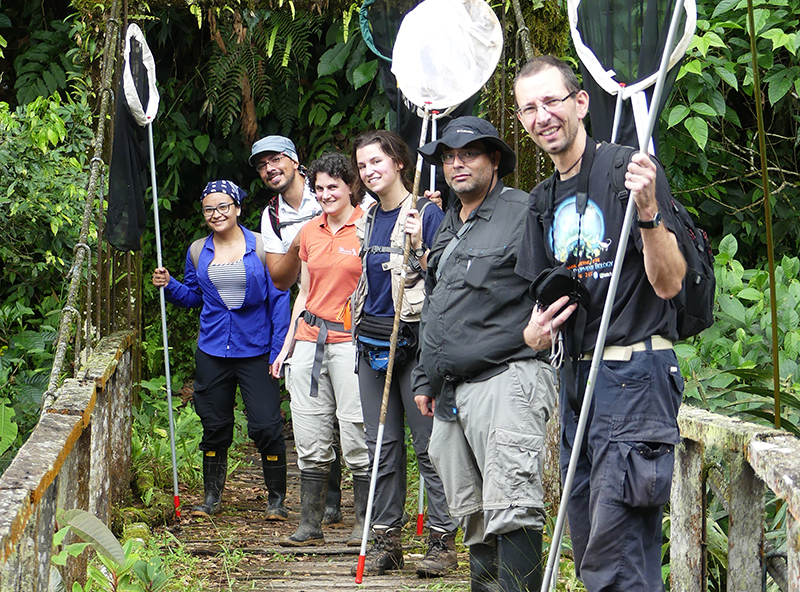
left=497, top=528, right=542, bottom=592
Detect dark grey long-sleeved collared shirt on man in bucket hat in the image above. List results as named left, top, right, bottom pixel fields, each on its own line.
left=420, top=181, right=537, bottom=421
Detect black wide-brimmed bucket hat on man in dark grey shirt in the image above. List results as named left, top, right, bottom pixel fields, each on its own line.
left=419, top=115, right=517, bottom=177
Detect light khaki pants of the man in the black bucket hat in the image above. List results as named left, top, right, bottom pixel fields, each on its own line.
left=429, top=360, right=556, bottom=545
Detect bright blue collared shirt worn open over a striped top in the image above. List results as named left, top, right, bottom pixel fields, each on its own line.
left=164, top=226, right=289, bottom=362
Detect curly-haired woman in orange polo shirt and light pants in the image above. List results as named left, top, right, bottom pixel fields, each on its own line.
left=268, top=154, right=369, bottom=547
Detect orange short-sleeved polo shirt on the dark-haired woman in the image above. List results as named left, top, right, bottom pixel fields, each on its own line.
left=295, top=206, right=364, bottom=343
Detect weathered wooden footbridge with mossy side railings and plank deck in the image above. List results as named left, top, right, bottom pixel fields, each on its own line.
left=0, top=332, right=800, bottom=592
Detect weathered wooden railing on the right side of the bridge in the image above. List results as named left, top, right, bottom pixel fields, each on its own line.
left=670, top=405, right=800, bottom=592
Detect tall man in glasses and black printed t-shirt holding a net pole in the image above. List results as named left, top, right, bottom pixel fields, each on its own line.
left=514, top=56, right=686, bottom=592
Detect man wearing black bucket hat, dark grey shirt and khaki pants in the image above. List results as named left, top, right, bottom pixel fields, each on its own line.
left=415, top=117, right=556, bottom=591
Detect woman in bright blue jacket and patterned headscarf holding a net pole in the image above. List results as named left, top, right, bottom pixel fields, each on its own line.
left=153, top=181, right=289, bottom=520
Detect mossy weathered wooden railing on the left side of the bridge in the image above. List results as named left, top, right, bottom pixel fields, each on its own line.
left=0, top=331, right=134, bottom=592
